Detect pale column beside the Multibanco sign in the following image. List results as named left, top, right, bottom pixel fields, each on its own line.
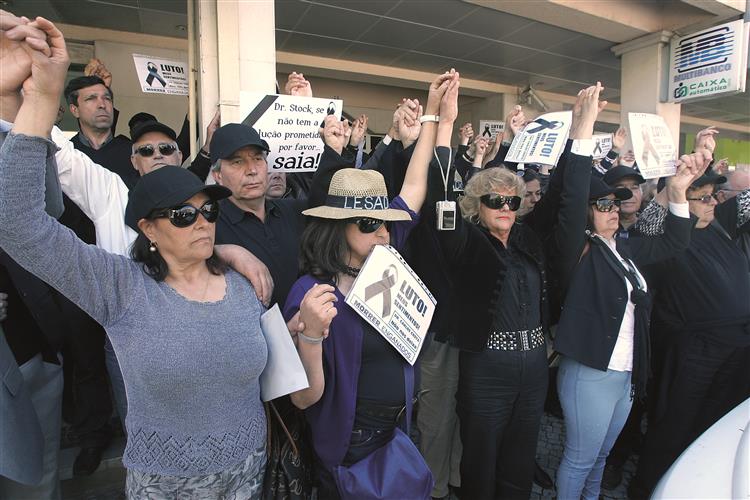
left=612, top=31, right=681, bottom=147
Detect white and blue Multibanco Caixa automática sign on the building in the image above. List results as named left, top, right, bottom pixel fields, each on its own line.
left=669, top=19, right=748, bottom=102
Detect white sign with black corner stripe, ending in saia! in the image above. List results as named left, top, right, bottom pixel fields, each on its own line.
left=240, top=92, right=343, bottom=172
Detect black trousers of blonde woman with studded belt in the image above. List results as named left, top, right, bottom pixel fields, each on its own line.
left=456, top=346, right=548, bottom=500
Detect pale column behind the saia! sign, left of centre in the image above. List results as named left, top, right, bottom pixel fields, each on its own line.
left=195, top=0, right=276, bottom=127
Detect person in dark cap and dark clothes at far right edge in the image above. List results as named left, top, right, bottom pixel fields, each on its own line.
left=629, top=167, right=750, bottom=498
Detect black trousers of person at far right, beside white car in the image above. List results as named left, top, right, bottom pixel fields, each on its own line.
left=633, top=334, right=750, bottom=494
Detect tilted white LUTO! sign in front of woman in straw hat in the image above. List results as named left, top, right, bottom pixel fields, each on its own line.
left=346, top=245, right=437, bottom=365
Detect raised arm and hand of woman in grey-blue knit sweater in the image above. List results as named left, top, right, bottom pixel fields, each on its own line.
left=0, top=18, right=137, bottom=326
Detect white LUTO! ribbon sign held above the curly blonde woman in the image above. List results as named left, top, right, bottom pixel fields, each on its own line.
left=505, top=111, right=573, bottom=165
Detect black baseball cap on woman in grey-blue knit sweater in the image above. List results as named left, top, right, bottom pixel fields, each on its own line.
left=125, top=166, right=232, bottom=232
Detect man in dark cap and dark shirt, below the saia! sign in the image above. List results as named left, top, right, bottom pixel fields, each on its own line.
left=211, top=123, right=307, bottom=305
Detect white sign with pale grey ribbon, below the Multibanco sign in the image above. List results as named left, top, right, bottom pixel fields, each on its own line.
left=628, top=113, right=677, bottom=179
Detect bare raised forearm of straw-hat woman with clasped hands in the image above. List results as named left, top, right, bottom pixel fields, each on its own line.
left=400, top=70, right=460, bottom=212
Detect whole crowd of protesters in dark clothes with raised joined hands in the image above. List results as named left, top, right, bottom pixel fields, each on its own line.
left=0, top=11, right=750, bottom=500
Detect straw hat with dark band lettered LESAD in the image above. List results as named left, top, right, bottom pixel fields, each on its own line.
left=302, top=168, right=411, bottom=221
